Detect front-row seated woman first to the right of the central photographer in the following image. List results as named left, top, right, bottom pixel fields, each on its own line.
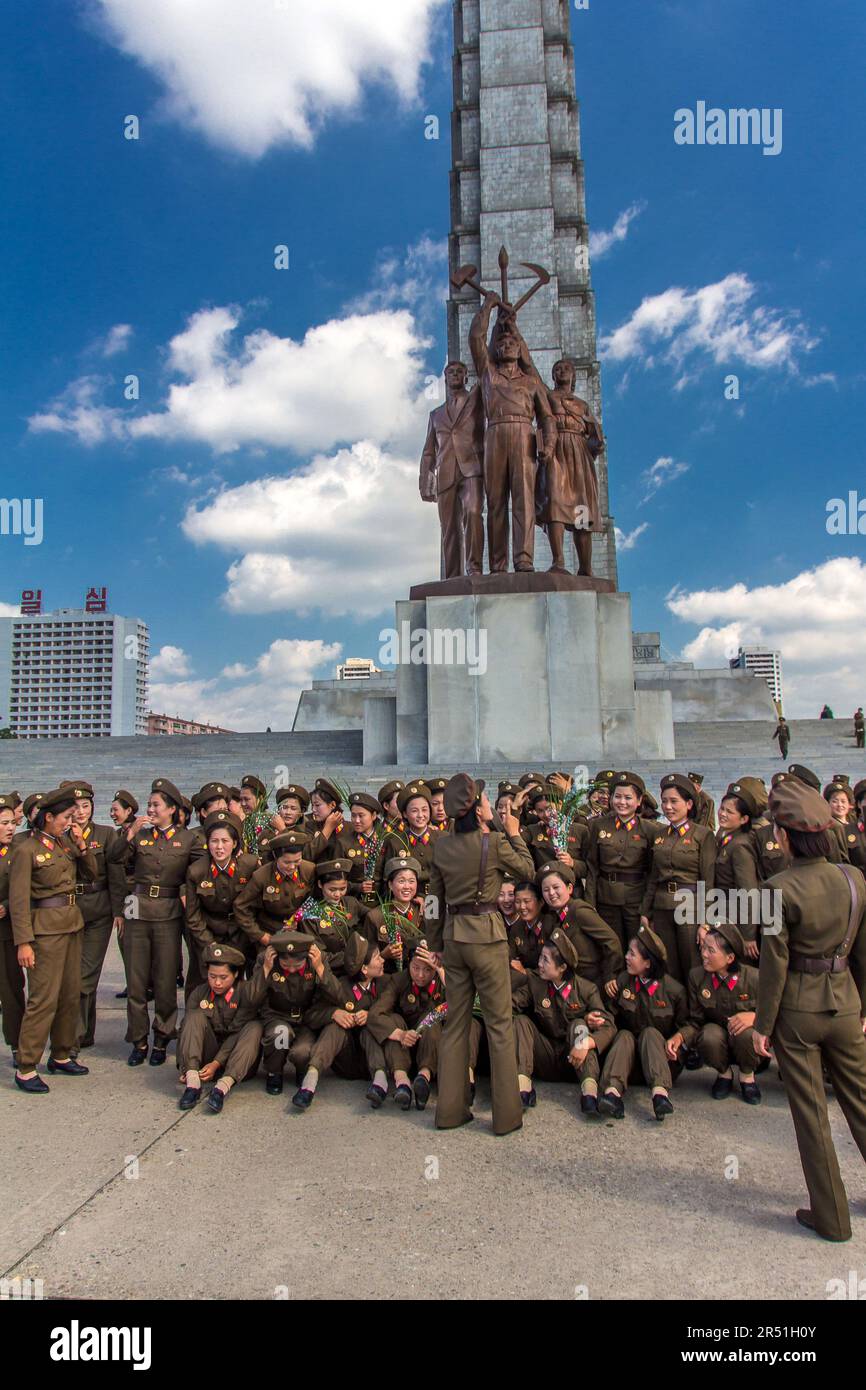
left=513, top=927, right=616, bottom=1118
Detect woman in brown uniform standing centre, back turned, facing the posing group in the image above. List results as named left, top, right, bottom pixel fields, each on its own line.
left=428, top=773, right=532, bottom=1134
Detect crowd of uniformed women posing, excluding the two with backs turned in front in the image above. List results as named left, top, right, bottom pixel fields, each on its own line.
left=0, top=765, right=866, bottom=1239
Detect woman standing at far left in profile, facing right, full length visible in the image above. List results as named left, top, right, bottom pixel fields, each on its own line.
left=10, top=787, right=96, bottom=1094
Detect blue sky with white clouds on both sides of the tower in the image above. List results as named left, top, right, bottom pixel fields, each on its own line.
left=0, top=0, right=866, bottom=728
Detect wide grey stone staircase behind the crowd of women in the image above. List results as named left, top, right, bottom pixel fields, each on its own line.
left=0, top=719, right=866, bottom=819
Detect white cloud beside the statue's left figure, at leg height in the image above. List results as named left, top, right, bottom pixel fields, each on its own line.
left=183, top=441, right=439, bottom=617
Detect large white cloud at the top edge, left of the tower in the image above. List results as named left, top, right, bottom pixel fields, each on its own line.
left=99, top=0, right=445, bottom=158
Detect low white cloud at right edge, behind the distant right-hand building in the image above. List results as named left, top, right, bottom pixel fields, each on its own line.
left=667, top=556, right=866, bottom=719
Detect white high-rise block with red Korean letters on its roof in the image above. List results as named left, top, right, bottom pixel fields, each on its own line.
left=0, top=589, right=150, bottom=738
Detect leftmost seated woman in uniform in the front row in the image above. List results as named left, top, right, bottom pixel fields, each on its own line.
left=178, top=942, right=265, bottom=1115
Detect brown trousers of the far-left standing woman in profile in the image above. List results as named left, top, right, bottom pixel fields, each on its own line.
left=18, top=927, right=83, bottom=1072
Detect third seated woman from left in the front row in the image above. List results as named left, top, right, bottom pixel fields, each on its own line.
left=292, top=931, right=388, bottom=1111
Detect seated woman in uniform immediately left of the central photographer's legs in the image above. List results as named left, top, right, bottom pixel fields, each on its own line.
left=367, top=942, right=445, bottom=1111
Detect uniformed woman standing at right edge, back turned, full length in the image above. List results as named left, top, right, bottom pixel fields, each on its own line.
left=755, top=777, right=866, bottom=1240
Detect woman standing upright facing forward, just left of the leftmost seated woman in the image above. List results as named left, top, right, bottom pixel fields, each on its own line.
left=115, top=777, right=203, bottom=1066
